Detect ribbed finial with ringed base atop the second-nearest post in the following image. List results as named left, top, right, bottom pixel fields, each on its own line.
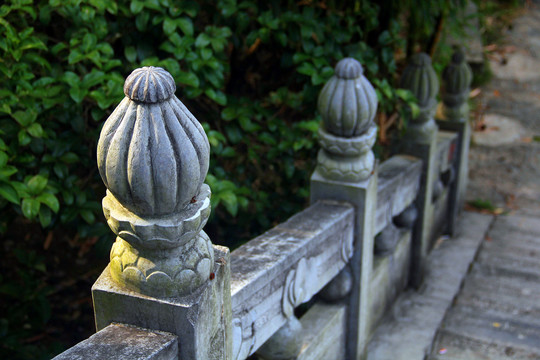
left=317, top=58, right=377, bottom=182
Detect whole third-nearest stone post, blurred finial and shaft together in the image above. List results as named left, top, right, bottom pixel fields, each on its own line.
left=400, top=53, right=439, bottom=287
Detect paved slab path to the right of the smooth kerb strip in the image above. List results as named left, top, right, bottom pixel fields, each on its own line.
left=428, top=5, right=540, bottom=360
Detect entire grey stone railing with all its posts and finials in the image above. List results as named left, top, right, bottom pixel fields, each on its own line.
left=52, top=50, right=471, bottom=360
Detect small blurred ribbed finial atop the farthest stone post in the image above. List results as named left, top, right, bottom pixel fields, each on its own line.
left=442, top=48, right=472, bottom=121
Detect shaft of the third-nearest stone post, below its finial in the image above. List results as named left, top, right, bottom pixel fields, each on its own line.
left=401, top=136, right=438, bottom=288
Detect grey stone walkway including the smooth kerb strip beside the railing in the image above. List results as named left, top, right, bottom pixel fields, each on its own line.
left=368, top=5, right=540, bottom=360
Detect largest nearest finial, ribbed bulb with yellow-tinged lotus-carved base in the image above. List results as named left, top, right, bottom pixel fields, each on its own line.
left=97, top=67, right=214, bottom=297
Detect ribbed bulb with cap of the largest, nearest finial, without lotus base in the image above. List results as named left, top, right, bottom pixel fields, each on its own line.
left=97, top=67, right=210, bottom=215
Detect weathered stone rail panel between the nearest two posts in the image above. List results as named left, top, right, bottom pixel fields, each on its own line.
left=231, top=201, right=354, bottom=359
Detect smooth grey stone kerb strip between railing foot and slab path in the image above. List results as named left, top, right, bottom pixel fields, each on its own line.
left=368, top=213, right=492, bottom=360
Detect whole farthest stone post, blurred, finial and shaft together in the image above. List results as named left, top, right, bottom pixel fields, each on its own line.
left=438, top=48, right=472, bottom=235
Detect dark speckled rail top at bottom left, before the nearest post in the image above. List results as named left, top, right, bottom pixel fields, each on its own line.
left=54, top=324, right=178, bottom=360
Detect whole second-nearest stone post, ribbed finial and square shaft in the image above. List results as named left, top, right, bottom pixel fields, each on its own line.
left=311, top=58, right=377, bottom=359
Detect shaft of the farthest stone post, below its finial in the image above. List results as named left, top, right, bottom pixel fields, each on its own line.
left=437, top=120, right=471, bottom=236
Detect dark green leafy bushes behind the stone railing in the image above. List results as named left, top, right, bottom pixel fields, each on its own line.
left=0, top=0, right=520, bottom=359
